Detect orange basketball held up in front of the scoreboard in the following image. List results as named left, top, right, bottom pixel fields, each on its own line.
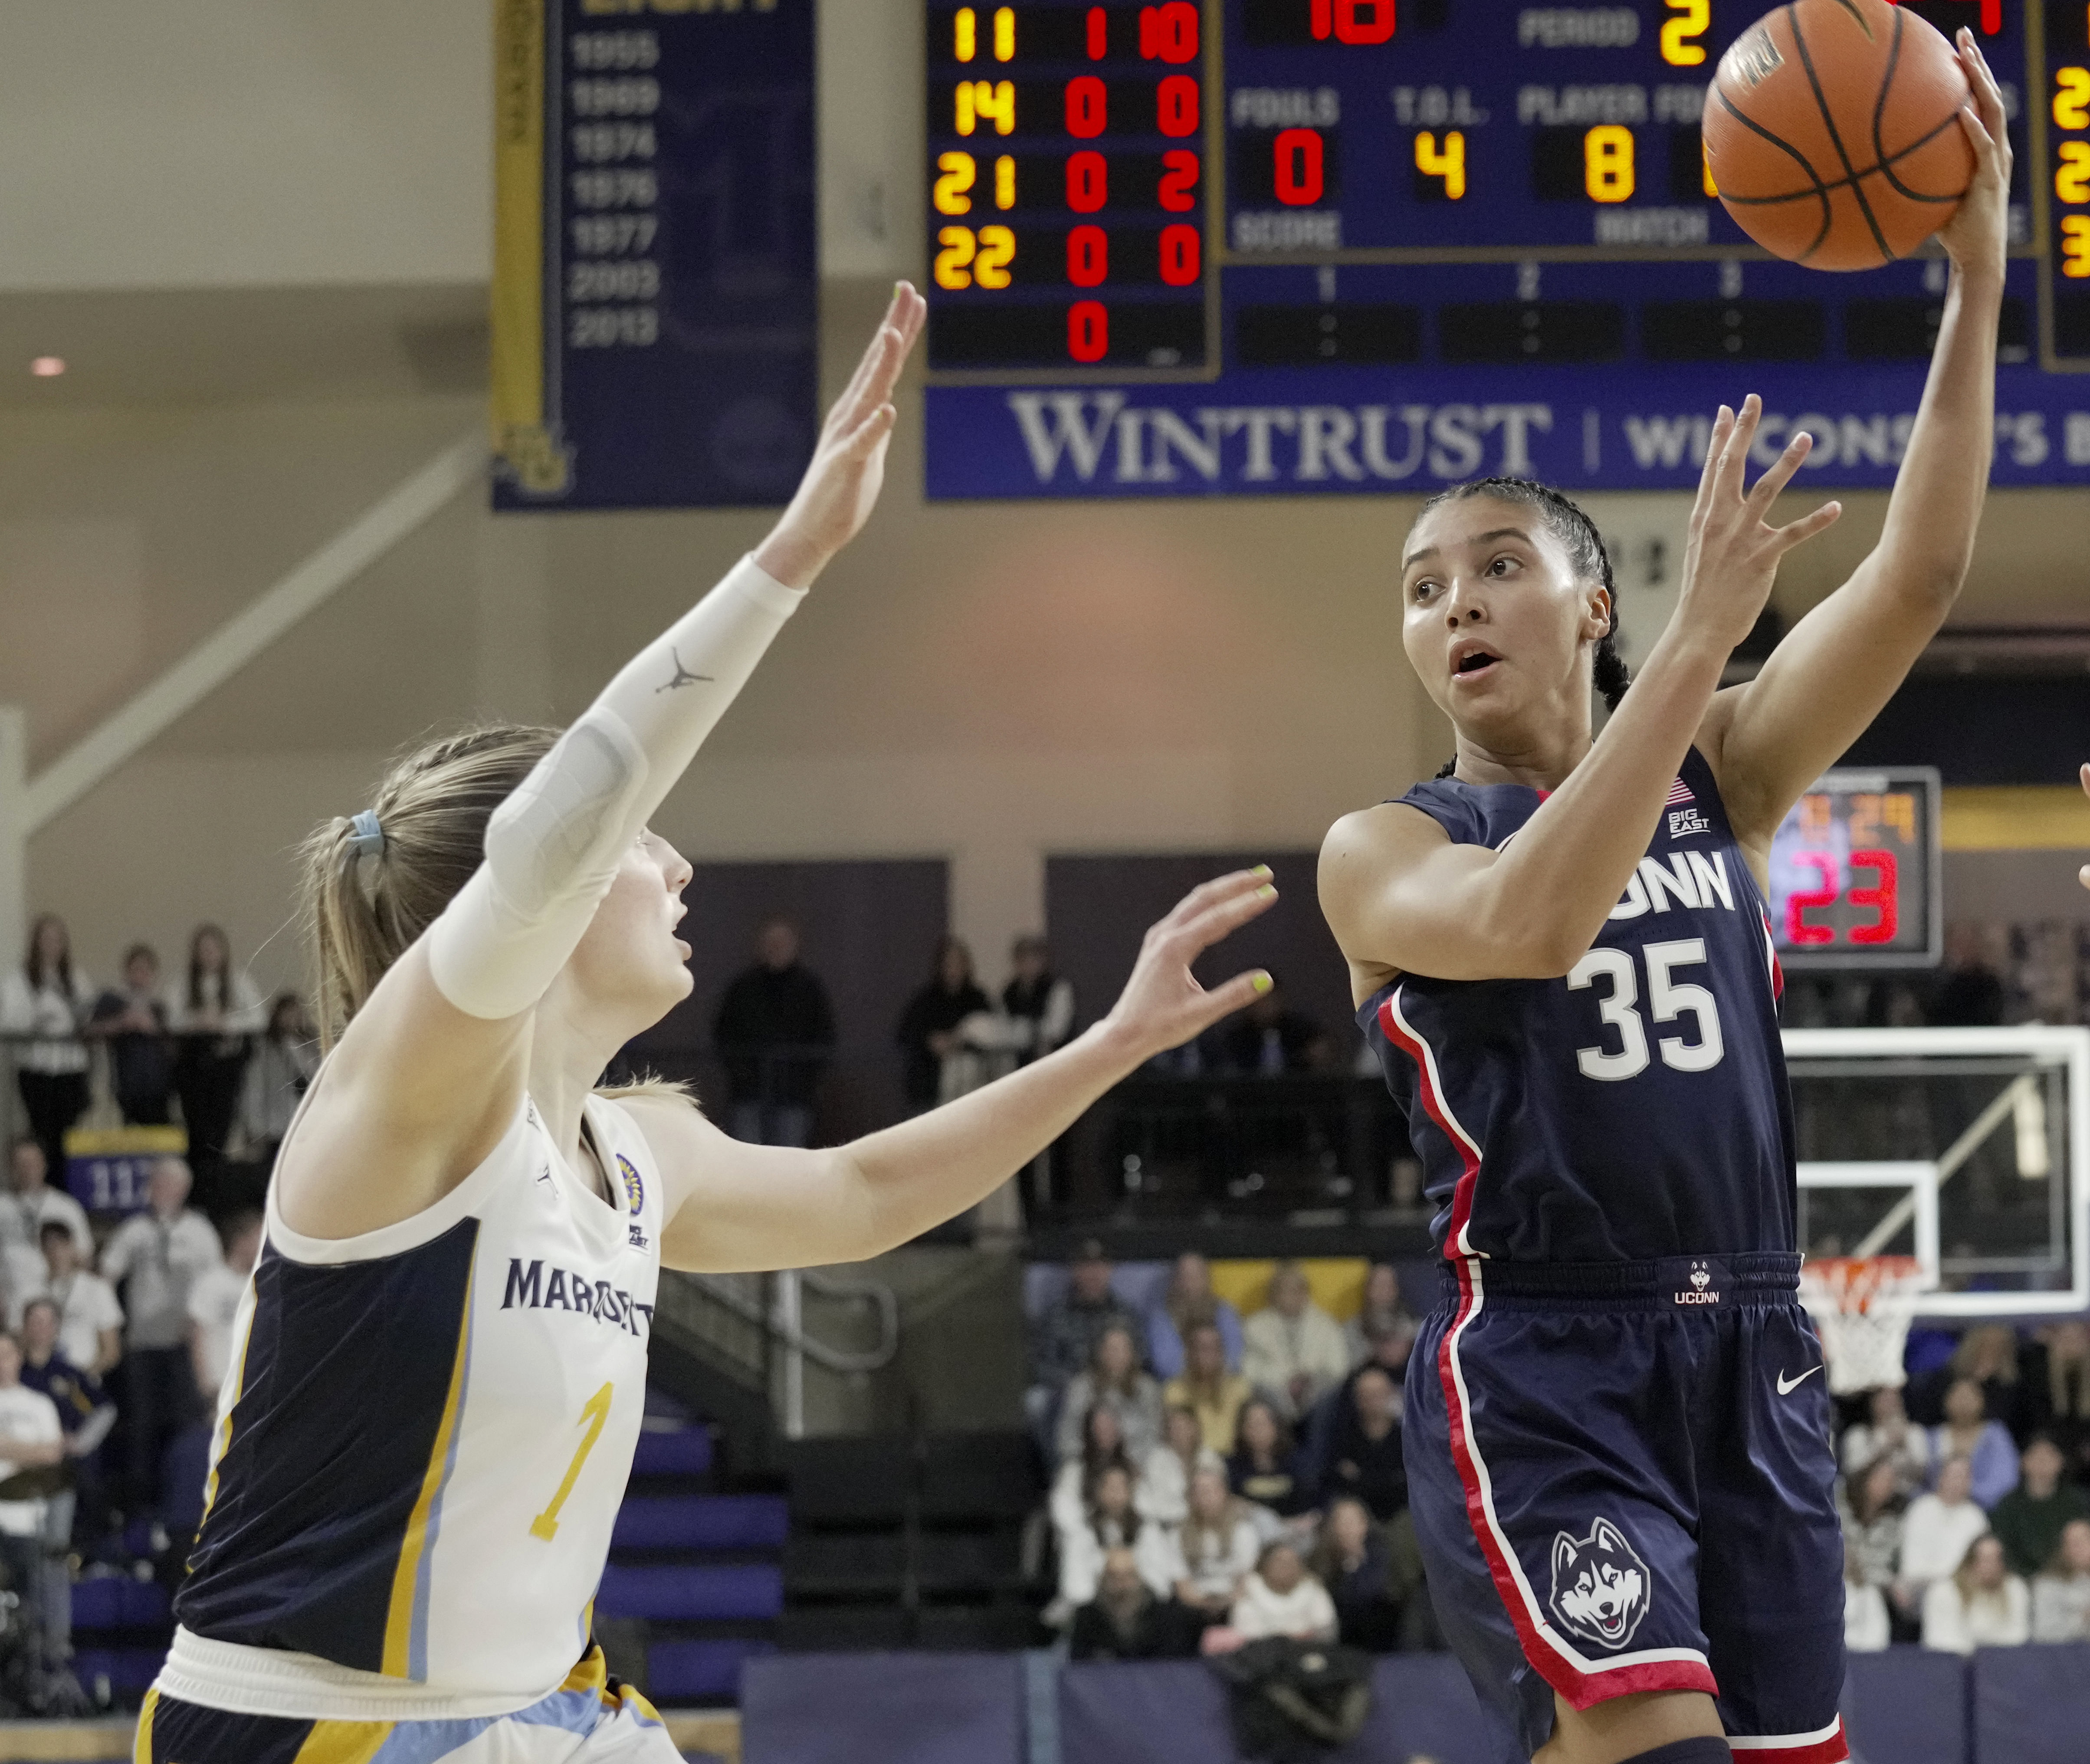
left=1706, top=0, right=1973, bottom=269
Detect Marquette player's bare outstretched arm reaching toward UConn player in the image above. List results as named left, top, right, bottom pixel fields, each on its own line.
left=643, top=870, right=1277, bottom=1273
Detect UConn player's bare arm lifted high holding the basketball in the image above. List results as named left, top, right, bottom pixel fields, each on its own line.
left=1703, top=29, right=2011, bottom=847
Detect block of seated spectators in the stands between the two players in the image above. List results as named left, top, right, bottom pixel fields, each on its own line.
left=1030, top=1242, right=1438, bottom=1659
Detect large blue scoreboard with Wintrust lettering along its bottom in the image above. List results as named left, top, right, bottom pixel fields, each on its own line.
left=922, top=0, right=2090, bottom=497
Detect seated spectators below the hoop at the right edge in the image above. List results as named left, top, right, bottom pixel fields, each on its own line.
left=1837, top=1319, right=2090, bottom=1653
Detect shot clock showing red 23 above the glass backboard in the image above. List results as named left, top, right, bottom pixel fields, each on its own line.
left=1770, top=767, right=1944, bottom=968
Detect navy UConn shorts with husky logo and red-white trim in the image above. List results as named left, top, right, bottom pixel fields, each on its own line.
left=1404, top=1254, right=1850, bottom=1764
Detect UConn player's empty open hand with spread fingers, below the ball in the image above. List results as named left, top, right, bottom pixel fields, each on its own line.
left=1678, top=393, right=1844, bottom=652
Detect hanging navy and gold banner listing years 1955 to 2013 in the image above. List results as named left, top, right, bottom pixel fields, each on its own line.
left=491, top=0, right=819, bottom=510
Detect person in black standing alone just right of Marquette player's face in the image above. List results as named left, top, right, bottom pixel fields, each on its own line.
left=711, top=916, right=836, bottom=1145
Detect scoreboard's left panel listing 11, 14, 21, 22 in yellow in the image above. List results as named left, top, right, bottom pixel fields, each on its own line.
left=928, top=0, right=1216, bottom=370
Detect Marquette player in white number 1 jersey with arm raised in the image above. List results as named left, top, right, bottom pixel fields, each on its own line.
left=136, top=284, right=1275, bottom=1764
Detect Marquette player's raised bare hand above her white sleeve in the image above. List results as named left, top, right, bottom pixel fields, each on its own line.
left=755, top=282, right=928, bottom=587
